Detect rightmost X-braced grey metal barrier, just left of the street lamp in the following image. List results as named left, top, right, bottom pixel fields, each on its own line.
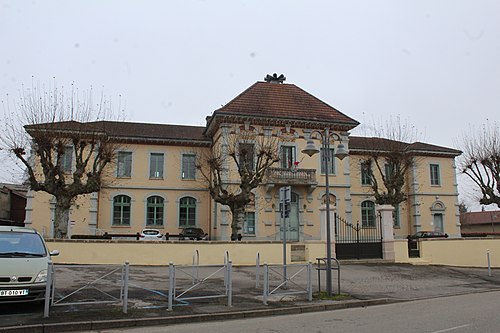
left=263, top=262, right=312, bottom=305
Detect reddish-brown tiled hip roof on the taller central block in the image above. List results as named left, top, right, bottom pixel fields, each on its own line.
left=213, top=82, right=359, bottom=129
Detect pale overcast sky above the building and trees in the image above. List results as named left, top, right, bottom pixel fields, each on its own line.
left=0, top=0, right=500, bottom=210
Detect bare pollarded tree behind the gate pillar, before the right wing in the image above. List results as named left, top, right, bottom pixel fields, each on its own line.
left=360, top=117, right=418, bottom=207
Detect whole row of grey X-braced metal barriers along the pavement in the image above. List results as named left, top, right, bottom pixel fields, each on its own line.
left=44, top=251, right=312, bottom=317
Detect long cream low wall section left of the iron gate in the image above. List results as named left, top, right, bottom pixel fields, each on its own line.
left=47, top=240, right=325, bottom=265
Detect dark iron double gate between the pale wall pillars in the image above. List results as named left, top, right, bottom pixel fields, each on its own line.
left=335, top=214, right=382, bottom=259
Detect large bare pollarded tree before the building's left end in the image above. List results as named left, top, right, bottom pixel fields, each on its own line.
left=0, top=83, right=123, bottom=238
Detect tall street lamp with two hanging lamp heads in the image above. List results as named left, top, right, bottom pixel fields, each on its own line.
left=302, top=128, right=349, bottom=296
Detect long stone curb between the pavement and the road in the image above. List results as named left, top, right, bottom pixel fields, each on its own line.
left=0, top=298, right=398, bottom=333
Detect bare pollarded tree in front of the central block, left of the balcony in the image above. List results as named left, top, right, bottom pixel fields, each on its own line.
left=197, top=128, right=279, bottom=240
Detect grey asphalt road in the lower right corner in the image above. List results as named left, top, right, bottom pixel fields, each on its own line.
left=81, top=291, right=500, bottom=333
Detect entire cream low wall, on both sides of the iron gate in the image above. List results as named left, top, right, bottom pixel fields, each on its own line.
left=47, top=238, right=500, bottom=267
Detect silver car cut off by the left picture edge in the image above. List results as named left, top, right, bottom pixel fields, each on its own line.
left=0, top=226, right=59, bottom=303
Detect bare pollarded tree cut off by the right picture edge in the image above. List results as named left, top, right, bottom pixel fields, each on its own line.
left=460, top=122, right=500, bottom=207
